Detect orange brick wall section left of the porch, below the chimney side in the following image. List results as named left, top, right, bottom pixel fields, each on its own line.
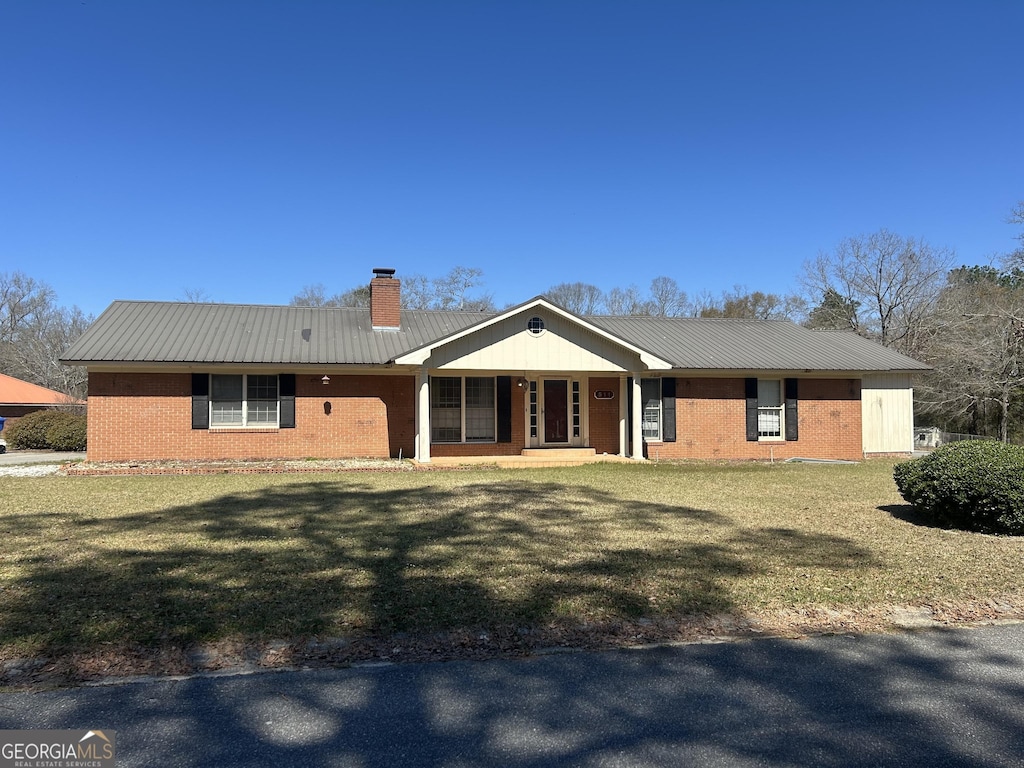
left=87, top=373, right=416, bottom=461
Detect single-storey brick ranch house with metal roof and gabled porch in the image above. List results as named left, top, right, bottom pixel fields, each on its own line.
left=63, top=269, right=928, bottom=463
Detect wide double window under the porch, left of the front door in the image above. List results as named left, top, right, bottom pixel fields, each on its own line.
left=430, top=376, right=497, bottom=442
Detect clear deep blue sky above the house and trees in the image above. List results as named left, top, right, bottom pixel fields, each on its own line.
left=0, top=0, right=1024, bottom=313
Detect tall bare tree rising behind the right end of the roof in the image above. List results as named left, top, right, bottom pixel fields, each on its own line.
left=803, top=229, right=952, bottom=353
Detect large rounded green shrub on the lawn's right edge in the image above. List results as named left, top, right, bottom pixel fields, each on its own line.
left=893, top=440, right=1024, bottom=536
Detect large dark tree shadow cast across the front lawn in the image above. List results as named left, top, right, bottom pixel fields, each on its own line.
left=0, top=480, right=871, bottom=654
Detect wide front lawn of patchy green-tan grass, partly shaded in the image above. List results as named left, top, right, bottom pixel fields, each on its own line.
left=0, top=462, right=1024, bottom=657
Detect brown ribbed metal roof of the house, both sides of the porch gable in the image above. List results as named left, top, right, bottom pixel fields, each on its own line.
left=63, top=301, right=928, bottom=372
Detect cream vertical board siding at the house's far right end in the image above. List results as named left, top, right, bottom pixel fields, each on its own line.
left=860, top=374, right=913, bottom=454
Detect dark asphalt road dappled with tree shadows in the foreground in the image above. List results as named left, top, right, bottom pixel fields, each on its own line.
left=0, top=625, right=1024, bottom=768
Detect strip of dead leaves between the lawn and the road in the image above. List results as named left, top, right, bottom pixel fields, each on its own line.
left=0, top=599, right=1024, bottom=691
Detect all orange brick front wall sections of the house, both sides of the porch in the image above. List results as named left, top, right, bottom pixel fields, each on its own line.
left=88, top=373, right=862, bottom=461
